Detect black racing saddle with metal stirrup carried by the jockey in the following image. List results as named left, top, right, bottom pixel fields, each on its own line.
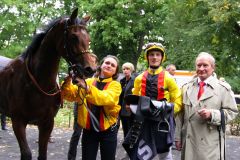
left=125, top=95, right=174, bottom=148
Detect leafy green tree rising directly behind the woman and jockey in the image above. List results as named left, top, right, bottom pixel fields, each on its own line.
left=79, top=0, right=172, bottom=65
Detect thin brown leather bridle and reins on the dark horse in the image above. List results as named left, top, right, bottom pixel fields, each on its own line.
left=25, top=19, right=89, bottom=96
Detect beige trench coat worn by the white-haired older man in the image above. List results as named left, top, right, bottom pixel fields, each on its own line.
left=176, top=77, right=238, bottom=160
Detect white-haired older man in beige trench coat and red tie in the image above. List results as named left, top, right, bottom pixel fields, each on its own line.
left=176, top=52, right=238, bottom=160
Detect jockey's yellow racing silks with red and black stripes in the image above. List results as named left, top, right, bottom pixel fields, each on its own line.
left=133, top=67, right=182, bottom=114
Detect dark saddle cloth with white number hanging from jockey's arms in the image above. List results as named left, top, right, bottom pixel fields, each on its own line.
left=122, top=95, right=175, bottom=160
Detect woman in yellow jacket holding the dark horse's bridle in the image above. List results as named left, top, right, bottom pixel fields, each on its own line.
left=62, top=55, right=121, bottom=160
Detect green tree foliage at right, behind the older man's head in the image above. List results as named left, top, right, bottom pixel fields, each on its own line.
left=164, top=0, right=240, bottom=93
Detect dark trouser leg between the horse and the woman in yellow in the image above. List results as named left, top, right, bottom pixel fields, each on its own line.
left=68, top=103, right=82, bottom=160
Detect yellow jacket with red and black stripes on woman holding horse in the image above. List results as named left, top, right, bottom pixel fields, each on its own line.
left=62, top=78, right=122, bottom=131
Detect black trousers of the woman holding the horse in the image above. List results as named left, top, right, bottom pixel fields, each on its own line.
left=82, top=126, right=118, bottom=160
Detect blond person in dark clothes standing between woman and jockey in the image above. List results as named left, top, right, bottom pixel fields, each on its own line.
left=119, top=62, right=135, bottom=158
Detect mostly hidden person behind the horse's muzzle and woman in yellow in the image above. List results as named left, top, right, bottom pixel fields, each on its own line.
left=68, top=53, right=98, bottom=160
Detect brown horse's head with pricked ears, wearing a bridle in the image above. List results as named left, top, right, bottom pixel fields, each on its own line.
left=63, top=9, right=95, bottom=77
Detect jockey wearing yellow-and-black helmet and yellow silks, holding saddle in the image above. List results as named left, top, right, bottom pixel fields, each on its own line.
left=130, top=42, right=182, bottom=160
